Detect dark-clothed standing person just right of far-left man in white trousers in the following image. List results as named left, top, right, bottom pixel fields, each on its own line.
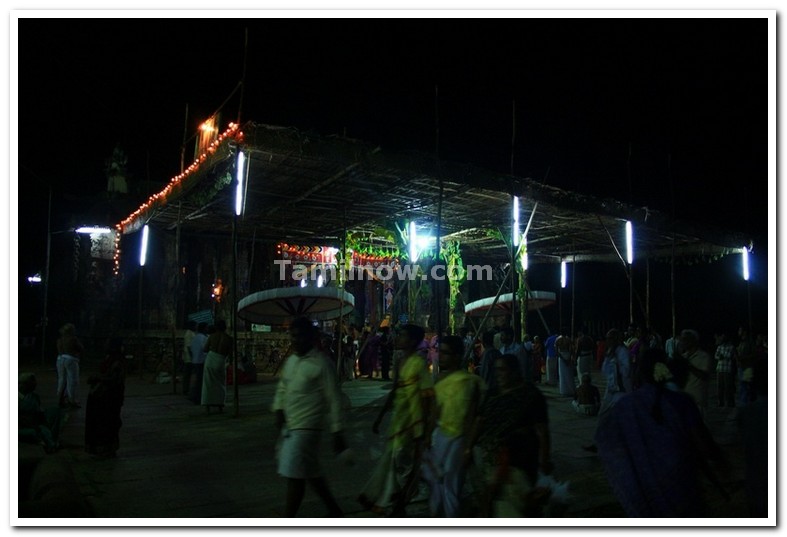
left=85, top=338, right=126, bottom=457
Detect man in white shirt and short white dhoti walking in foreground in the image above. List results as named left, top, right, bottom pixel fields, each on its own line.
left=272, top=317, right=346, bottom=517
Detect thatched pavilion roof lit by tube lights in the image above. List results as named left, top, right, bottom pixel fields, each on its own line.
left=115, top=122, right=749, bottom=263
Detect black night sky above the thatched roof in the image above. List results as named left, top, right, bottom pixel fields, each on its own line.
left=12, top=18, right=769, bottom=340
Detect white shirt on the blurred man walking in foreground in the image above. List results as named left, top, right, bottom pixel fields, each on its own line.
left=271, top=348, right=342, bottom=433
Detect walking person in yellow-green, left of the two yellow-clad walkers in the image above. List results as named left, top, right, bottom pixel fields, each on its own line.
left=358, top=324, right=434, bottom=516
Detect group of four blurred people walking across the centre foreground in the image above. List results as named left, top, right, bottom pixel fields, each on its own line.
left=273, top=319, right=552, bottom=517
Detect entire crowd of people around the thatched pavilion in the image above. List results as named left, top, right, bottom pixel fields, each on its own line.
left=19, top=318, right=768, bottom=517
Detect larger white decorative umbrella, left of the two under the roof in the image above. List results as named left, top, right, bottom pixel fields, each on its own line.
left=238, top=287, right=355, bottom=324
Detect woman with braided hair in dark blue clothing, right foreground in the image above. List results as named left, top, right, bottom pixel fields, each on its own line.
left=595, top=349, right=726, bottom=517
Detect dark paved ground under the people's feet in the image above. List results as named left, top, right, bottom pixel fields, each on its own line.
left=20, top=358, right=746, bottom=526
